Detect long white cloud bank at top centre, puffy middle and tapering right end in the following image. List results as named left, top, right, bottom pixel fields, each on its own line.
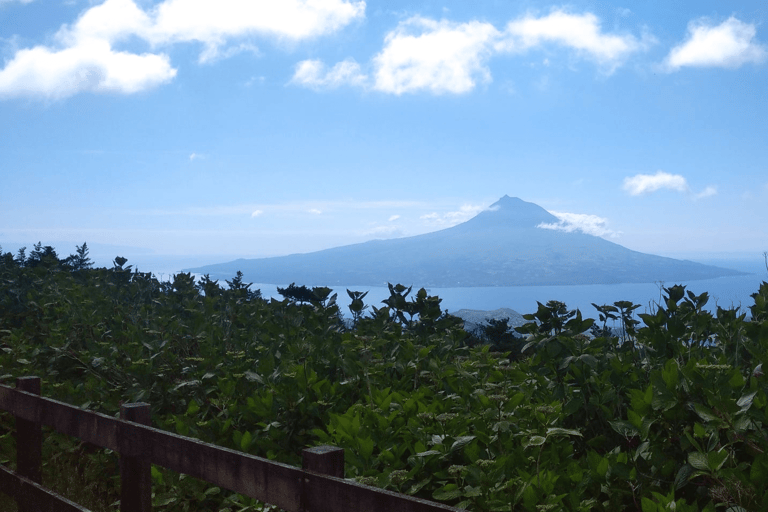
left=292, top=10, right=653, bottom=95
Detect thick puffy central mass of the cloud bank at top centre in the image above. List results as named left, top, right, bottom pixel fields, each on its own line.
left=373, top=16, right=499, bottom=95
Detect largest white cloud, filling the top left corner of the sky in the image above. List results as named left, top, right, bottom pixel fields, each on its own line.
left=0, top=0, right=365, bottom=99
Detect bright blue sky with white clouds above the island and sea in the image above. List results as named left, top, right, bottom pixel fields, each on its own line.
left=0, top=0, right=768, bottom=257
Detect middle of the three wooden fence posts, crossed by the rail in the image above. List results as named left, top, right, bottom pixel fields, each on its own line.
left=120, top=402, right=152, bottom=512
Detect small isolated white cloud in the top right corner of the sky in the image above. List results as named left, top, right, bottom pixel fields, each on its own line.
left=664, top=17, right=768, bottom=71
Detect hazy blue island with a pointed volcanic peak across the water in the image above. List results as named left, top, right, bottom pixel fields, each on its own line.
left=185, top=196, right=744, bottom=288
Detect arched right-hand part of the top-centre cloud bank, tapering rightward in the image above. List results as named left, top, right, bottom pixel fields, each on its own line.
left=497, top=9, right=653, bottom=72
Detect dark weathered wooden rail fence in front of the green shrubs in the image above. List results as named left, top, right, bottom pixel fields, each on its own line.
left=0, top=377, right=458, bottom=512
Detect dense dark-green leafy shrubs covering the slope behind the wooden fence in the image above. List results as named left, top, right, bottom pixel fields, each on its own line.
left=0, top=244, right=768, bottom=512
